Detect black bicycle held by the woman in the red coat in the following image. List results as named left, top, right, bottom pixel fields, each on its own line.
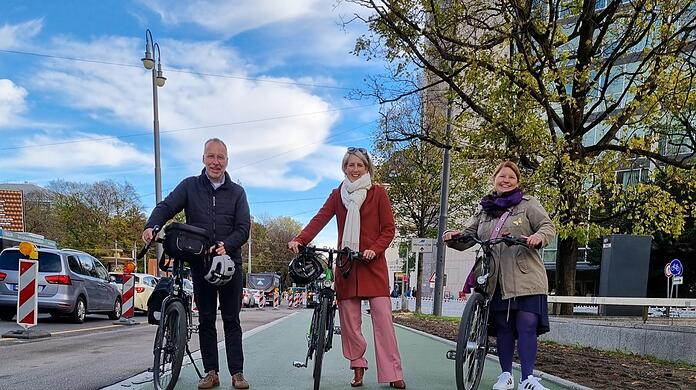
left=293, top=246, right=362, bottom=390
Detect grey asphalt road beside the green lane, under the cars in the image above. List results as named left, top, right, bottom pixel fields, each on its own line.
left=0, top=309, right=288, bottom=390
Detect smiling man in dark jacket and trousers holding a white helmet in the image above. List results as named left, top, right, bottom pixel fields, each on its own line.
left=143, top=138, right=251, bottom=389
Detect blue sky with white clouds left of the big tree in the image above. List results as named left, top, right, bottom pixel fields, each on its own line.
left=0, top=0, right=383, bottom=245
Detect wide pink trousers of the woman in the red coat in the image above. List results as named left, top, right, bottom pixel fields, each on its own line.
left=338, top=297, right=404, bottom=383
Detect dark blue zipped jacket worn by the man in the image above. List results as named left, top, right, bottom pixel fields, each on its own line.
left=145, top=168, right=251, bottom=263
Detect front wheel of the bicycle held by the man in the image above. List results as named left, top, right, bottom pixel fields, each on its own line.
left=152, top=301, right=187, bottom=390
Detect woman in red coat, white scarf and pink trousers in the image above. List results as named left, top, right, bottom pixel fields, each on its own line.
left=288, top=148, right=406, bottom=389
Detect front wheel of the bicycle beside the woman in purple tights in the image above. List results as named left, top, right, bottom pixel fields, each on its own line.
left=455, top=292, right=488, bottom=390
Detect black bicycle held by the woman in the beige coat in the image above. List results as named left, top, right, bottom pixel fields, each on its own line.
left=447, top=235, right=527, bottom=390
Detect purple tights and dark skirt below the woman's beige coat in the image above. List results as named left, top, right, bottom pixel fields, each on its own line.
left=493, top=310, right=539, bottom=378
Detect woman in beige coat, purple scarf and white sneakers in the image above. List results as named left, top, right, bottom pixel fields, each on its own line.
left=443, top=161, right=556, bottom=390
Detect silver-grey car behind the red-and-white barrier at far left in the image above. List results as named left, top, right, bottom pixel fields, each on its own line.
left=0, top=247, right=121, bottom=323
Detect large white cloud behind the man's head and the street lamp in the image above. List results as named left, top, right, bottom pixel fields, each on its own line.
left=25, top=37, right=339, bottom=190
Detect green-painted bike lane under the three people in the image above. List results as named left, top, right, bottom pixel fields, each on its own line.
left=114, top=310, right=584, bottom=390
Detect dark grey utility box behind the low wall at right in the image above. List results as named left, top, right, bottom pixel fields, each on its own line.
left=599, top=234, right=652, bottom=316
